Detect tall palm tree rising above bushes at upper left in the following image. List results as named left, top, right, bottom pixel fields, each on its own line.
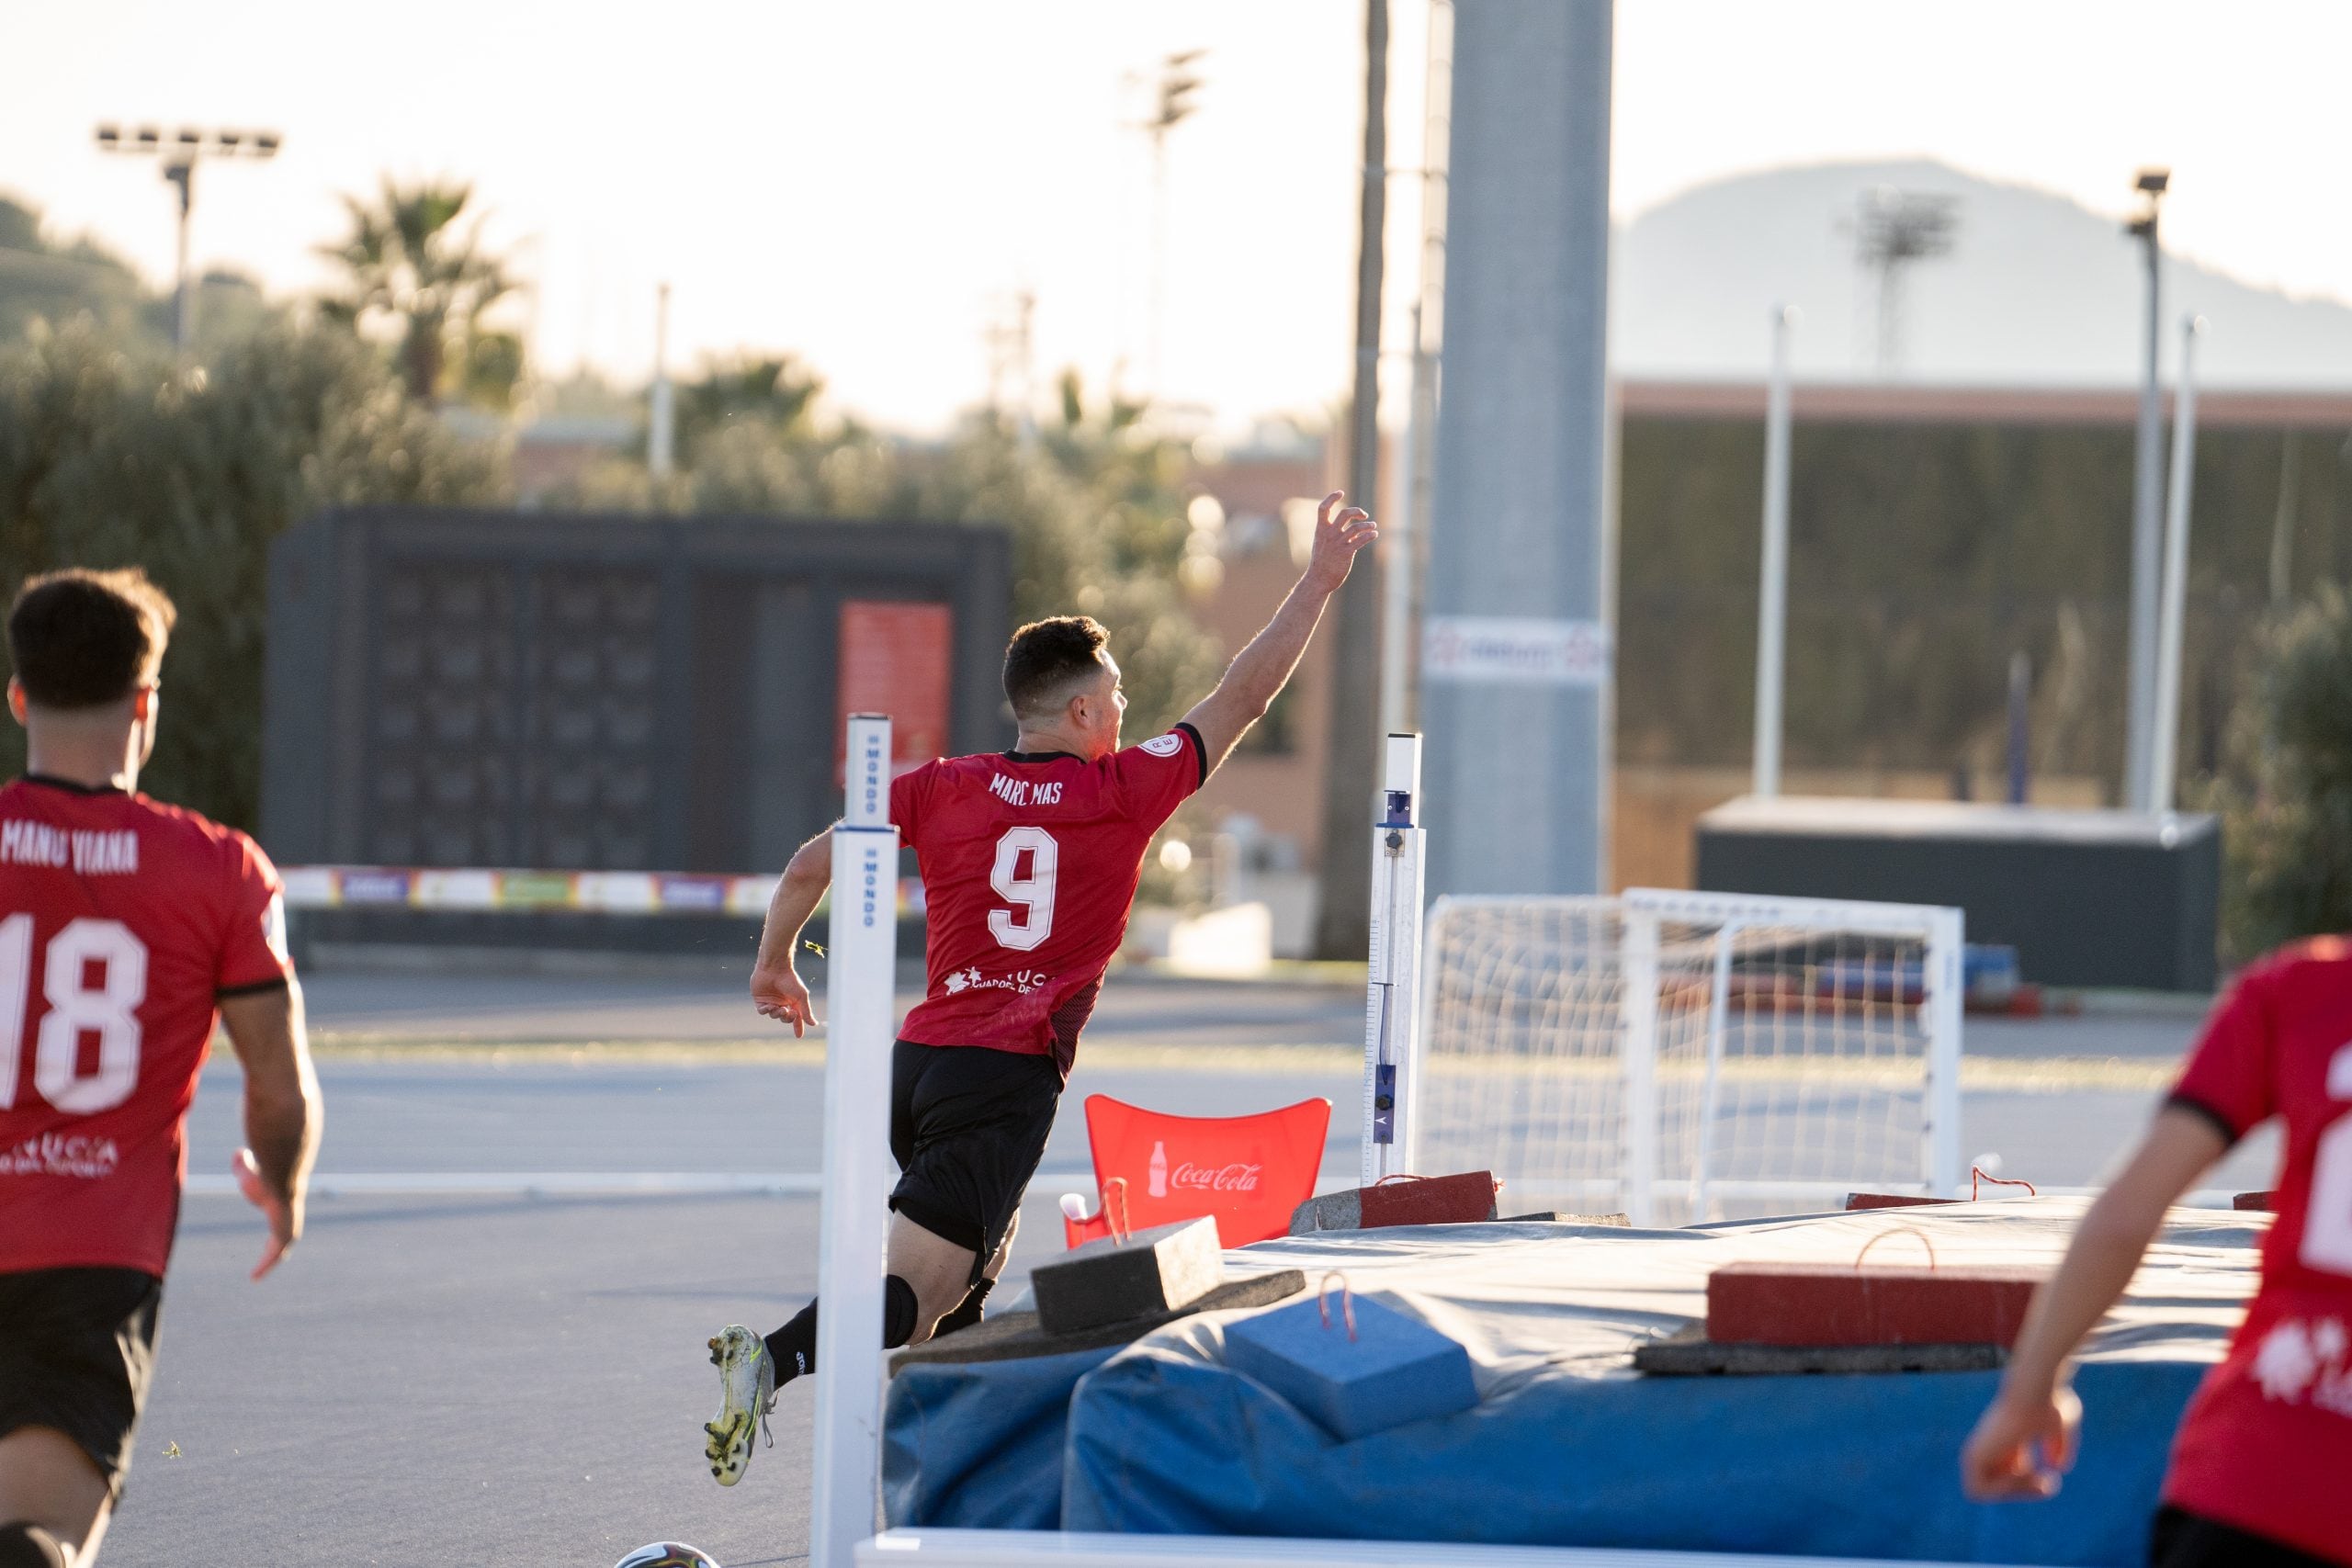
left=318, top=176, right=522, bottom=407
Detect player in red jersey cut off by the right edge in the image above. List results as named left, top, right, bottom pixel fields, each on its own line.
left=1962, top=938, right=2352, bottom=1568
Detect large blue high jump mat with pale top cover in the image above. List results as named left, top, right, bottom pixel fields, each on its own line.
left=885, top=1199, right=2267, bottom=1568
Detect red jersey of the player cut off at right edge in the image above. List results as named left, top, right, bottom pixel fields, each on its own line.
left=2164, top=938, right=2352, bottom=1563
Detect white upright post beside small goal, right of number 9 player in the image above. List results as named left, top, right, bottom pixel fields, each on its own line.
left=1362, top=736, right=1428, bottom=1187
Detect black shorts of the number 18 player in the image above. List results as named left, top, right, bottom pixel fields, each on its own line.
left=0, top=1269, right=163, bottom=1500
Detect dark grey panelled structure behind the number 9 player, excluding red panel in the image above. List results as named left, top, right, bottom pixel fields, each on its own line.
left=261, top=508, right=1012, bottom=872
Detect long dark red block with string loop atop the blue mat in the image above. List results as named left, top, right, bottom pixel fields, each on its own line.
left=1708, top=1262, right=2041, bottom=1347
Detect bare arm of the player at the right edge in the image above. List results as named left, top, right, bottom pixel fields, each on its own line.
left=1959, top=1107, right=2227, bottom=1500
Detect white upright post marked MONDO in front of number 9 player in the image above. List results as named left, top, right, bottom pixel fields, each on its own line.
left=809, top=712, right=899, bottom=1568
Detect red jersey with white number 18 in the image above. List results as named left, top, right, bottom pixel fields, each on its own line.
left=0, top=776, right=294, bottom=1277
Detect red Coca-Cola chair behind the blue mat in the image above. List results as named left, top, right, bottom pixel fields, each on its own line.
left=1061, top=1096, right=1331, bottom=1246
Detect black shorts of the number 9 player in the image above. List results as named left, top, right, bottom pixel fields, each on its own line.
left=889, top=1039, right=1061, bottom=1279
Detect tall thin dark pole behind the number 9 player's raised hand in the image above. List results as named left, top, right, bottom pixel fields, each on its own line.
left=1315, top=0, right=1387, bottom=959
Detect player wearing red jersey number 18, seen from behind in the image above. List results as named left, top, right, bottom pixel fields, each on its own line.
left=0, top=571, right=320, bottom=1568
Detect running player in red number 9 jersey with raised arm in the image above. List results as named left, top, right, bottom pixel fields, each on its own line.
left=706, top=491, right=1378, bottom=1485
